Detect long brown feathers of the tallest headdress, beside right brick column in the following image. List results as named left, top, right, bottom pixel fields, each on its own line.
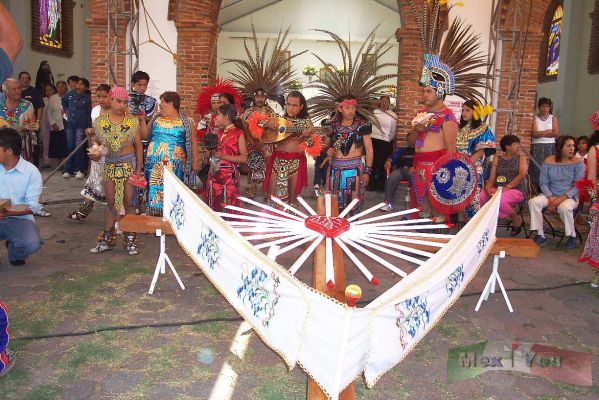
left=408, top=0, right=488, bottom=101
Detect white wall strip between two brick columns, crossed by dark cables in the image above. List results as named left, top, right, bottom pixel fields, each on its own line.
left=139, top=0, right=177, bottom=98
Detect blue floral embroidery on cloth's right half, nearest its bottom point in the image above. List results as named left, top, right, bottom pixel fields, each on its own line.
left=395, top=296, right=430, bottom=349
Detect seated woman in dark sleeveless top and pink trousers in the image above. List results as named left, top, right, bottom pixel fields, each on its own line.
left=480, top=135, right=528, bottom=236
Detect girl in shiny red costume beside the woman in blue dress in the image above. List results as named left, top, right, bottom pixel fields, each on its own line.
left=203, top=104, right=247, bottom=211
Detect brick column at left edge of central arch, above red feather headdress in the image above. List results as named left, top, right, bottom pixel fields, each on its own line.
left=171, top=0, right=221, bottom=120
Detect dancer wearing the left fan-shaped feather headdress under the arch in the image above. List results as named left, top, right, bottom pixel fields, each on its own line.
left=225, top=24, right=305, bottom=202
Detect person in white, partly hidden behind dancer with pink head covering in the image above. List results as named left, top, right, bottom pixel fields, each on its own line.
left=65, top=83, right=110, bottom=222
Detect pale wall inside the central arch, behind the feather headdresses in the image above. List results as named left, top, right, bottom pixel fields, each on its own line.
left=217, top=0, right=400, bottom=97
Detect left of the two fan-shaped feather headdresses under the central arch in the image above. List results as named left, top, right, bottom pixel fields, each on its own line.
left=224, top=24, right=307, bottom=98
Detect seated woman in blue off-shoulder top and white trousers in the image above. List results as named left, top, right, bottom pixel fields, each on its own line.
left=528, top=135, right=584, bottom=249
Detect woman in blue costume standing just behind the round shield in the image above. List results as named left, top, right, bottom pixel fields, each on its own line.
left=456, top=100, right=496, bottom=218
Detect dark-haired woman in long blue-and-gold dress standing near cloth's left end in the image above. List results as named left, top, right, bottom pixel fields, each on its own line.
left=146, top=92, right=200, bottom=216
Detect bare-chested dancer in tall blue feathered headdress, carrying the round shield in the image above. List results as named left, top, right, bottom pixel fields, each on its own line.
left=408, top=0, right=487, bottom=219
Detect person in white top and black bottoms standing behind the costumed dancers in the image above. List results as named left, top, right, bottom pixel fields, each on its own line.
left=367, top=96, right=397, bottom=192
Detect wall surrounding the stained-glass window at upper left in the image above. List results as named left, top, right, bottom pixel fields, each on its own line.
left=4, top=0, right=90, bottom=85
